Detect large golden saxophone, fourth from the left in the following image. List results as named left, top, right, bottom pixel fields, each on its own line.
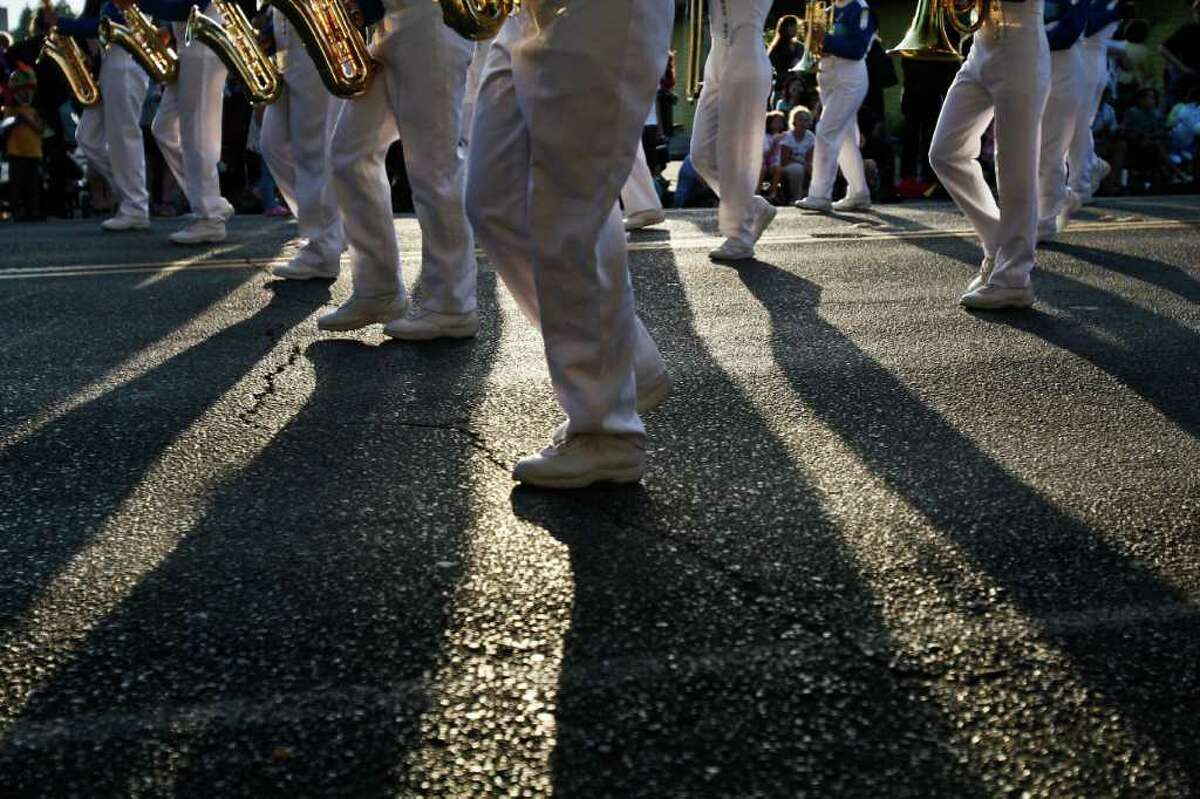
left=268, top=0, right=376, bottom=100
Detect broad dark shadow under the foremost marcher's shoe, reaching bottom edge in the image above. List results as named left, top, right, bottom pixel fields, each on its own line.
left=512, top=256, right=978, bottom=797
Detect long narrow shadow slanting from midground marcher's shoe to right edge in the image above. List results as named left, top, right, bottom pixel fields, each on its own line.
left=738, top=253, right=1200, bottom=786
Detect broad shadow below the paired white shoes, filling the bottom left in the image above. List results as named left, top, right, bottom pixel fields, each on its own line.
left=0, top=276, right=499, bottom=797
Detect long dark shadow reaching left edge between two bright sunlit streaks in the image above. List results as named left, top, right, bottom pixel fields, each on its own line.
left=0, top=275, right=329, bottom=633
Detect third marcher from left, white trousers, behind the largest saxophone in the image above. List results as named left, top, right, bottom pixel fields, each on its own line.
left=262, top=8, right=344, bottom=281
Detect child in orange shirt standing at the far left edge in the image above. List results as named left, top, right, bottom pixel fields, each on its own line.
left=4, top=64, right=46, bottom=222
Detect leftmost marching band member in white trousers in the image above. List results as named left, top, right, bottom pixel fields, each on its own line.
left=54, top=0, right=150, bottom=232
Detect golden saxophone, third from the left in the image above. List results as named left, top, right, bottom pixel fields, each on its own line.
left=184, top=0, right=283, bottom=106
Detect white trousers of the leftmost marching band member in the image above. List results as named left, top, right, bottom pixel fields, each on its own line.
left=76, top=47, right=150, bottom=220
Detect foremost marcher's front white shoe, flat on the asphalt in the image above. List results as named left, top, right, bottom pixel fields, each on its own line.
left=512, top=435, right=646, bottom=488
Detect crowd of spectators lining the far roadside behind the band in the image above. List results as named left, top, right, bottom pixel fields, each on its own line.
left=7, top=0, right=1200, bottom=220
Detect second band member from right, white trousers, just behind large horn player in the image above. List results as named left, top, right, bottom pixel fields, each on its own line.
left=1038, top=0, right=1088, bottom=241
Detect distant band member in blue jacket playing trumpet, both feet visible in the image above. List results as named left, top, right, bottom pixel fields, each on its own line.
left=796, top=0, right=876, bottom=211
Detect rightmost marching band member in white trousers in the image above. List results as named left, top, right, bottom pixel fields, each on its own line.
left=1067, top=0, right=1121, bottom=203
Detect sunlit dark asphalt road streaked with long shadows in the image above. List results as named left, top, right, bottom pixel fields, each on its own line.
left=0, top=198, right=1200, bottom=799
